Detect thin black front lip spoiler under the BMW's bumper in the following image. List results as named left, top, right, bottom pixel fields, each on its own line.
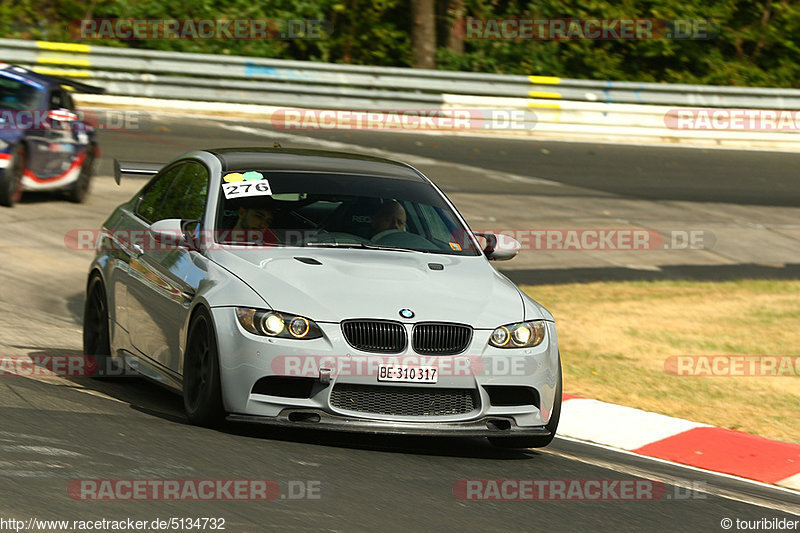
left=227, top=408, right=550, bottom=438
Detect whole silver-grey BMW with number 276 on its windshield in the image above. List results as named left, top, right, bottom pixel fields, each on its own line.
left=79, top=147, right=561, bottom=447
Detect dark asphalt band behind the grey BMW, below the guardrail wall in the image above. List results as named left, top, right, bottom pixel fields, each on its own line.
left=92, top=114, right=800, bottom=206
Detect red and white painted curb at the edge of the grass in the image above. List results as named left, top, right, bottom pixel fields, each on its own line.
left=558, top=394, right=800, bottom=490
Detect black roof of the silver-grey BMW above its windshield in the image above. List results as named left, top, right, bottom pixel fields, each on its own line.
left=207, top=147, right=427, bottom=182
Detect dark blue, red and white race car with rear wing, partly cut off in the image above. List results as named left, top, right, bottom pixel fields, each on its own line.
left=0, top=63, right=102, bottom=206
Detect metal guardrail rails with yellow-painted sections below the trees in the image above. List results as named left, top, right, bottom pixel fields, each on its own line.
left=0, top=39, right=800, bottom=109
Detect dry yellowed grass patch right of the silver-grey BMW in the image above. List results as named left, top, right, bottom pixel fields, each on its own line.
left=523, top=280, right=800, bottom=443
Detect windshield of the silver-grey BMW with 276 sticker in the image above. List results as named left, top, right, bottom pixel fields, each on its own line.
left=216, top=171, right=480, bottom=255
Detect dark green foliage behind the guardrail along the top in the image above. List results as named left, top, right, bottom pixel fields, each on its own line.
left=0, top=0, right=800, bottom=87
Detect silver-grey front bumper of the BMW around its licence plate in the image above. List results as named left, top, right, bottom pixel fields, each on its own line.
left=212, top=307, right=559, bottom=437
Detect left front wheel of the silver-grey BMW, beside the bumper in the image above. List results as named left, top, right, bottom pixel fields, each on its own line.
left=183, top=308, right=225, bottom=427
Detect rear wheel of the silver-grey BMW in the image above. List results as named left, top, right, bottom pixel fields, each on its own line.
left=83, top=274, right=119, bottom=378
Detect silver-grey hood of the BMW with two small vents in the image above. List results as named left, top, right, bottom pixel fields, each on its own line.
left=208, top=248, right=536, bottom=329
